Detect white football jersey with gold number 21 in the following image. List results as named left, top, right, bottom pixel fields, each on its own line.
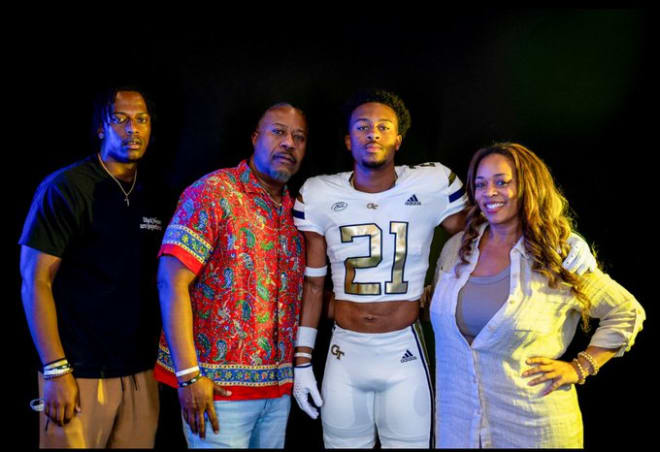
left=293, top=163, right=467, bottom=303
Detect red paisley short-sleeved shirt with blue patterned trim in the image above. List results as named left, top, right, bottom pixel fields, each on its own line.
left=155, top=161, right=305, bottom=400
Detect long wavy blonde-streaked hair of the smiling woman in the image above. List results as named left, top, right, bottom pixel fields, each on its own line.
left=456, top=143, right=591, bottom=331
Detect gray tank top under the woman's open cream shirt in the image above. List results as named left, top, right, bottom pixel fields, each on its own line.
left=456, top=266, right=511, bottom=344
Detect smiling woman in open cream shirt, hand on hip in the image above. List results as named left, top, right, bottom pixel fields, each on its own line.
left=430, top=143, right=645, bottom=448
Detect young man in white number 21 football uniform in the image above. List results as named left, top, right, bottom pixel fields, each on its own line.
left=293, top=90, right=590, bottom=448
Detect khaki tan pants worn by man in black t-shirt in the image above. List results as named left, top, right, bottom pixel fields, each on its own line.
left=39, top=370, right=159, bottom=448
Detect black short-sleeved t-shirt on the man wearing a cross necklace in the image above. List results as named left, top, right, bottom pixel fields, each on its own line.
left=19, top=155, right=166, bottom=378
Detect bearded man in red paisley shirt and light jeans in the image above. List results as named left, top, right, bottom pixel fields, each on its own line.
left=155, top=104, right=307, bottom=448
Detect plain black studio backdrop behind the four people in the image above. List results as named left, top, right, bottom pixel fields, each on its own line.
left=9, top=9, right=657, bottom=448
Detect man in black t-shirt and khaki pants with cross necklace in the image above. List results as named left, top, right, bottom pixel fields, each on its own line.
left=19, top=90, right=165, bottom=448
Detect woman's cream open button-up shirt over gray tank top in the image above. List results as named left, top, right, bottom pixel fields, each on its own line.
left=430, top=224, right=645, bottom=448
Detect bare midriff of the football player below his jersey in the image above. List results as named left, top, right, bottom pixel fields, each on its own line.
left=334, top=300, right=419, bottom=333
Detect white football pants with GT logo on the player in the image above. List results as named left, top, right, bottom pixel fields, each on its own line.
left=321, top=321, right=433, bottom=448
